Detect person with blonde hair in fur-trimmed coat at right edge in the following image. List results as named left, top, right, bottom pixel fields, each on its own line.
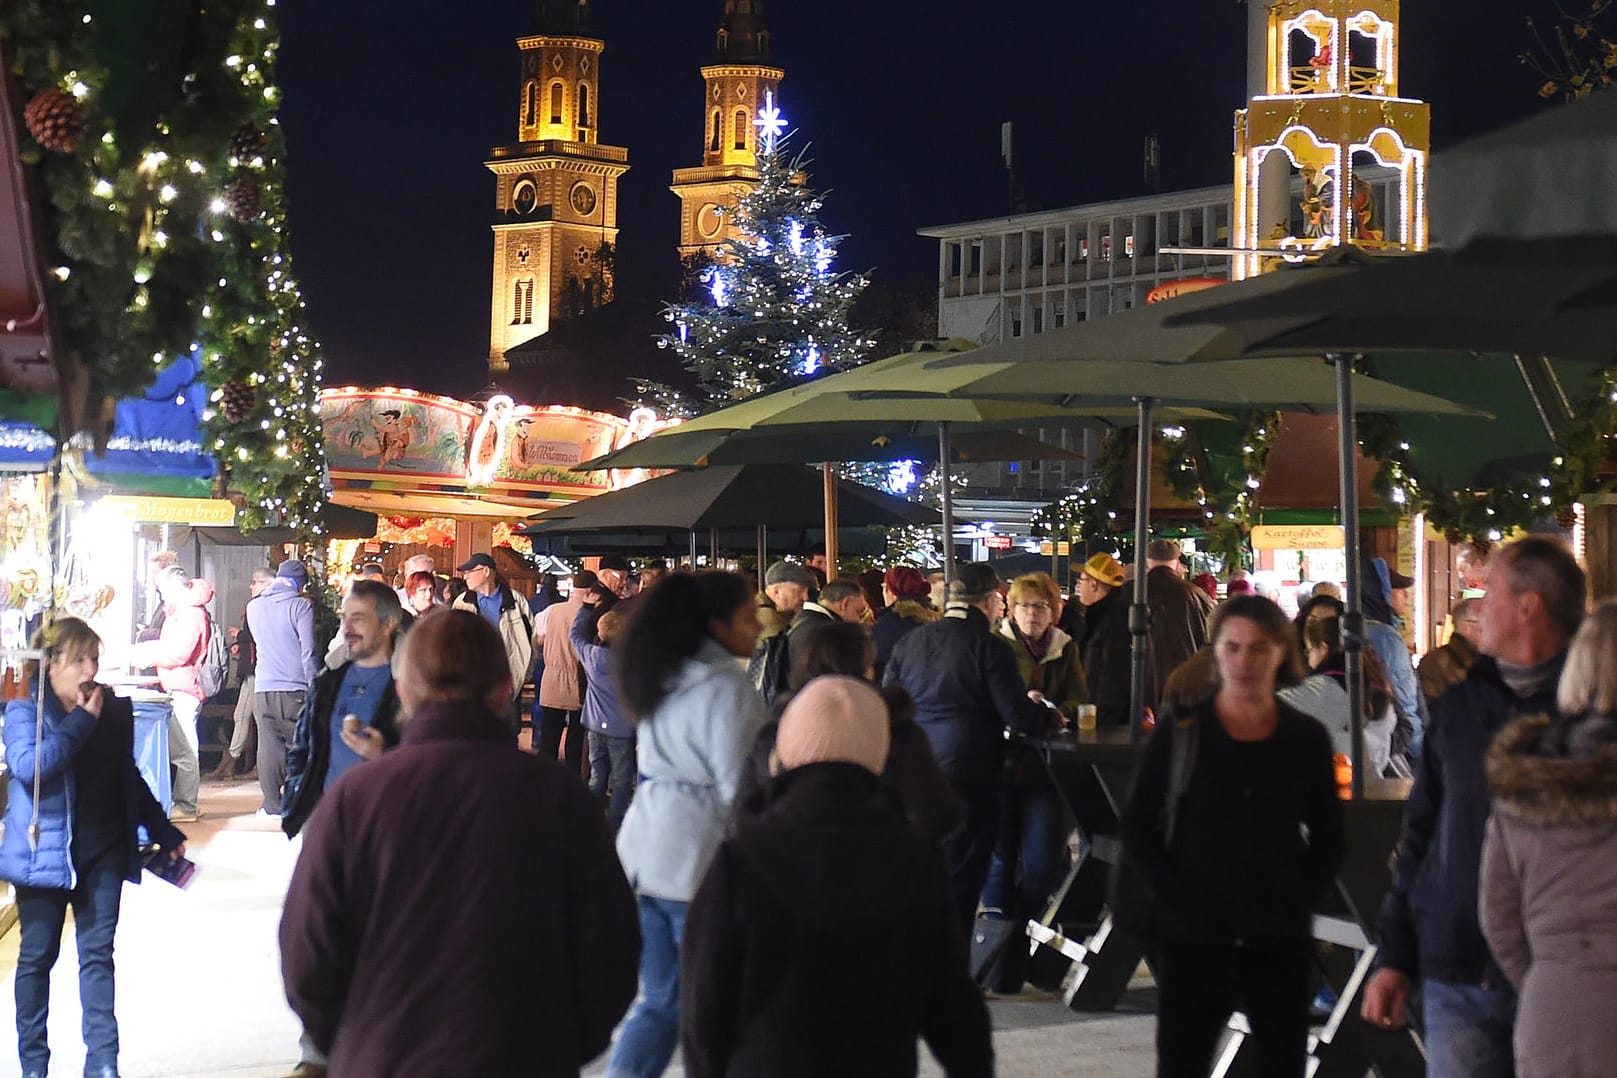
left=1481, top=596, right=1617, bottom=1078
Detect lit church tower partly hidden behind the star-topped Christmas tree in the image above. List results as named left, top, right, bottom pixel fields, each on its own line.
left=669, top=0, right=786, bottom=259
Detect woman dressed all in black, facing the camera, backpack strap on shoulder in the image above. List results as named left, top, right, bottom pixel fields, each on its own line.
left=1122, top=595, right=1344, bottom=1078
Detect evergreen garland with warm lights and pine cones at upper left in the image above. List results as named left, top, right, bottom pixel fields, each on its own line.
left=0, top=0, right=325, bottom=541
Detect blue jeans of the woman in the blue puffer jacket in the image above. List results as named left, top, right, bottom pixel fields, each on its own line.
left=16, top=850, right=123, bottom=1075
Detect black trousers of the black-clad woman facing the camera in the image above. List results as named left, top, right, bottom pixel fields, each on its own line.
left=1155, top=941, right=1313, bottom=1078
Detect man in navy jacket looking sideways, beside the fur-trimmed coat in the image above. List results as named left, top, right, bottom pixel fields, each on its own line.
left=1363, top=535, right=1585, bottom=1078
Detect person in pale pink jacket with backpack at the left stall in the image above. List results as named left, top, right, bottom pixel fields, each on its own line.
left=131, top=566, right=211, bottom=823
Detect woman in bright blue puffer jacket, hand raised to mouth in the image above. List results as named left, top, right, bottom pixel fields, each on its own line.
left=0, top=617, right=186, bottom=1078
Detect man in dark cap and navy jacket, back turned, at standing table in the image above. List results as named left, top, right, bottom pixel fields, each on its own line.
left=883, top=562, right=1054, bottom=929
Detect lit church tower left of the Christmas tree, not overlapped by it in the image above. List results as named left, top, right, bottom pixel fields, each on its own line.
left=485, top=0, right=629, bottom=373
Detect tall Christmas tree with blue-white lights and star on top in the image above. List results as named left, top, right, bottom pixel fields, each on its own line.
left=660, top=95, right=872, bottom=404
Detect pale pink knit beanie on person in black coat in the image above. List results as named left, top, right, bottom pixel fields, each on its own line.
left=773, top=674, right=891, bottom=774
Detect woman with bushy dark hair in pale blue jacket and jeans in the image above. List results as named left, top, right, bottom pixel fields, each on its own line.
left=606, top=572, right=768, bottom=1078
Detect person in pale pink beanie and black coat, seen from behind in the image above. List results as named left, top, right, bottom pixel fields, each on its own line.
left=679, top=676, right=993, bottom=1078
